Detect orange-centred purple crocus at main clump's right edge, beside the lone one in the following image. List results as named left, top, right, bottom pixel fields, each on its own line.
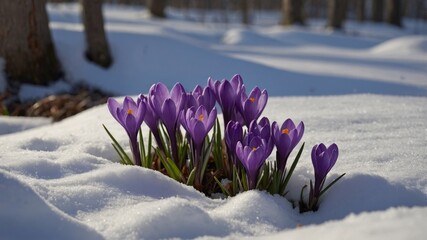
left=271, top=118, right=304, bottom=172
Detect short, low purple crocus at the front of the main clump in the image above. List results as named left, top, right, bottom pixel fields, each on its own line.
left=236, top=136, right=271, bottom=190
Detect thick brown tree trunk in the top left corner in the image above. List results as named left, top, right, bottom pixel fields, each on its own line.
left=0, top=0, right=62, bottom=85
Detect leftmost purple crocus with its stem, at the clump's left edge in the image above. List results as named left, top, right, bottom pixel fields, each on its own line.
left=107, top=97, right=147, bottom=166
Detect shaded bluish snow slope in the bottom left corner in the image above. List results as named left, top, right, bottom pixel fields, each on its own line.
left=0, top=169, right=102, bottom=239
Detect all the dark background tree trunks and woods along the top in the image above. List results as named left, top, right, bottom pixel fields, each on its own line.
left=0, top=0, right=427, bottom=84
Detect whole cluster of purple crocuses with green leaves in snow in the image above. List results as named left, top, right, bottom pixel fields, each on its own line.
left=104, top=75, right=344, bottom=211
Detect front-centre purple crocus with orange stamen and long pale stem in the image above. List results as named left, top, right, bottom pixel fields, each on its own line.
left=180, top=105, right=217, bottom=190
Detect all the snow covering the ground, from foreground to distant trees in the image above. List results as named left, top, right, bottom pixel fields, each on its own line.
left=0, top=4, right=427, bottom=240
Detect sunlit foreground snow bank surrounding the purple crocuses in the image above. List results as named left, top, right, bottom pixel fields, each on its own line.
left=0, top=95, right=427, bottom=239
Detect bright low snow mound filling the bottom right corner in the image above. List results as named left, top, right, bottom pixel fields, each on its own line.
left=262, top=207, right=427, bottom=240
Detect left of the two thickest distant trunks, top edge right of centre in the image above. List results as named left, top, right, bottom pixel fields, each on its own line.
left=282, top=0, right=305, bottom=25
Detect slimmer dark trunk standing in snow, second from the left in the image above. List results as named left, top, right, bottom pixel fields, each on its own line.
left=80, top=0, right=113, bottom=68
